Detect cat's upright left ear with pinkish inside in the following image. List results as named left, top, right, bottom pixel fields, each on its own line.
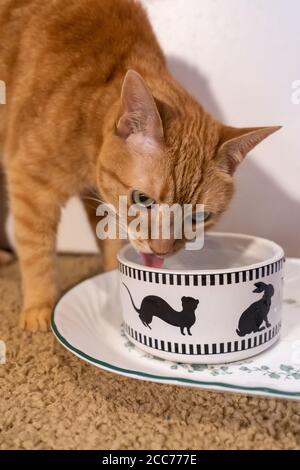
left=116, top=70, right=163, bottom=143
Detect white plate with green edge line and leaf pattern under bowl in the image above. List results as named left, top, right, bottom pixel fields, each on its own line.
left=52, top=259, right=300, bottom=400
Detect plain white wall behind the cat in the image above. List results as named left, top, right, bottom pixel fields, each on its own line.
left=5, top=0, right=300, bottom=256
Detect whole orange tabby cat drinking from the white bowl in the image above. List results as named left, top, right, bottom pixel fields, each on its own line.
left=0, top=0, right=278, bottom=331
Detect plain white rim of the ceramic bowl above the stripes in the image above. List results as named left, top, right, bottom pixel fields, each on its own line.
left=117, top=232, right=285, bottom=276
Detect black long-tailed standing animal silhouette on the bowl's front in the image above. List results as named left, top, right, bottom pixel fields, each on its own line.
left=124, top=284, right=199, bottom=336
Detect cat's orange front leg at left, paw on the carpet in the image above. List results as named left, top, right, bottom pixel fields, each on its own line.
left=7, top=168, right=60, bottom=332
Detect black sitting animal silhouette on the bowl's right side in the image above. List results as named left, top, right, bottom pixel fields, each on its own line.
left=236, top=282, right=274, bottom=336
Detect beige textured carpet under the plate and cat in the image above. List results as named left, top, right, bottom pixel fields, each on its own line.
left=0, top=256, right=300, bottom=450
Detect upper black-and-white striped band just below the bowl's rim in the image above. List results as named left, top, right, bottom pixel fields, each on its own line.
left=119, top=258, right=285, bottom=286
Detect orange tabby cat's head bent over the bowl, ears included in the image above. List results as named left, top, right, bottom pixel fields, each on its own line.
left=98, top=71, right=280, bottom=266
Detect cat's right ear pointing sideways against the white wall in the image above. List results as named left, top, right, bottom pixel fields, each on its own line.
left=217, top=126, right=281, bottom=174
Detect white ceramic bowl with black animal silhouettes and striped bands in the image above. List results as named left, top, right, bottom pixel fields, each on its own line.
left=119, top=233, right=284, bottom=364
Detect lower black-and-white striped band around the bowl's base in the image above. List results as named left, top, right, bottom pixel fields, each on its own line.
left=124, top=322, right=281, bottom=356
